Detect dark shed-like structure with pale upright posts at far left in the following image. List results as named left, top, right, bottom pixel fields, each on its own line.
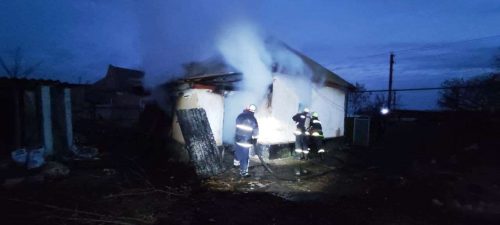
left=0, top=77, right=77, bottom=158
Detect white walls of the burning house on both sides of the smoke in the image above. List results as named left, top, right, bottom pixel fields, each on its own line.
left=172, top=74, right=345, bottom=145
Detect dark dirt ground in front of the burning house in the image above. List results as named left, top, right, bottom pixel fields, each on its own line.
left=0, top=118, right=500, bottom=225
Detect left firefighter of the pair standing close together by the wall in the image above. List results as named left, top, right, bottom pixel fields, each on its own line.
left=292, top=108, right=311, bottom=159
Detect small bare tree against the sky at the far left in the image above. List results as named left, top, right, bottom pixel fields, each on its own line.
left=0, top=47, right=42, bottom=77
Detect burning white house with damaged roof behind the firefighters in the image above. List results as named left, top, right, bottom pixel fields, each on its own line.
left=171, top=40, right=353, bottom=160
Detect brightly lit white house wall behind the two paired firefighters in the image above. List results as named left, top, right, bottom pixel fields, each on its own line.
left=256, top=74, right=345, bottom=144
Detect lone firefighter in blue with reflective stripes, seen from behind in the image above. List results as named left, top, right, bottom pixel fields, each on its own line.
left=234, top=104, right=259, bottom=177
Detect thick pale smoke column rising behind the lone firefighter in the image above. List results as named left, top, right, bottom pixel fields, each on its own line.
left=217, top=23, right=272, bottom=142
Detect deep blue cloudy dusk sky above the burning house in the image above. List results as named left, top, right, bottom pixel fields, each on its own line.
left=0, top=0, right=500, bottom=109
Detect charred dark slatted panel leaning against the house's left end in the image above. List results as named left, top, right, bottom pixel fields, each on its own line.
left=177, top=108, right=224, bottom=177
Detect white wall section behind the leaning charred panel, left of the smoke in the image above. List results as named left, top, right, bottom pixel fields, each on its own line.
left=172, top=89, right=224, bottom=145
